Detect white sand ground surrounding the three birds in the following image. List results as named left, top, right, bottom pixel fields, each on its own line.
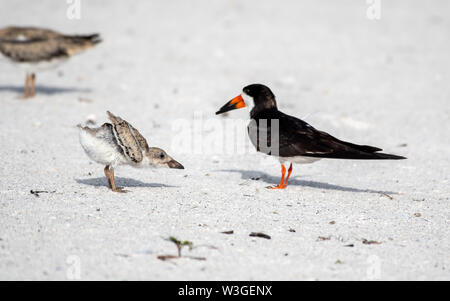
left=0, top=0, right=450, bottom=280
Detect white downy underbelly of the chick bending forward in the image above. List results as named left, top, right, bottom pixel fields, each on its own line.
left=79, top=130, right=123, bottom=167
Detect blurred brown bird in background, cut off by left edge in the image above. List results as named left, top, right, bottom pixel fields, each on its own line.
left=0, top=26, right=101, bottom=98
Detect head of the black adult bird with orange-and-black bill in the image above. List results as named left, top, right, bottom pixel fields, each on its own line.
left=216, top=84, right=277, bottom=116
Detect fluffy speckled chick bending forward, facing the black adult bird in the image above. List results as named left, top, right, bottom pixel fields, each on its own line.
left=79, top=111, right=184, bottom=192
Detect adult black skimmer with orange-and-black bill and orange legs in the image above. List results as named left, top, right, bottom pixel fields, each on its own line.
left=216, top=84, right=406, bottom=189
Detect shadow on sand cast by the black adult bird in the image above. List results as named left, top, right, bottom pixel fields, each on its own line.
left=218, top=169, right=398, bottom=195
